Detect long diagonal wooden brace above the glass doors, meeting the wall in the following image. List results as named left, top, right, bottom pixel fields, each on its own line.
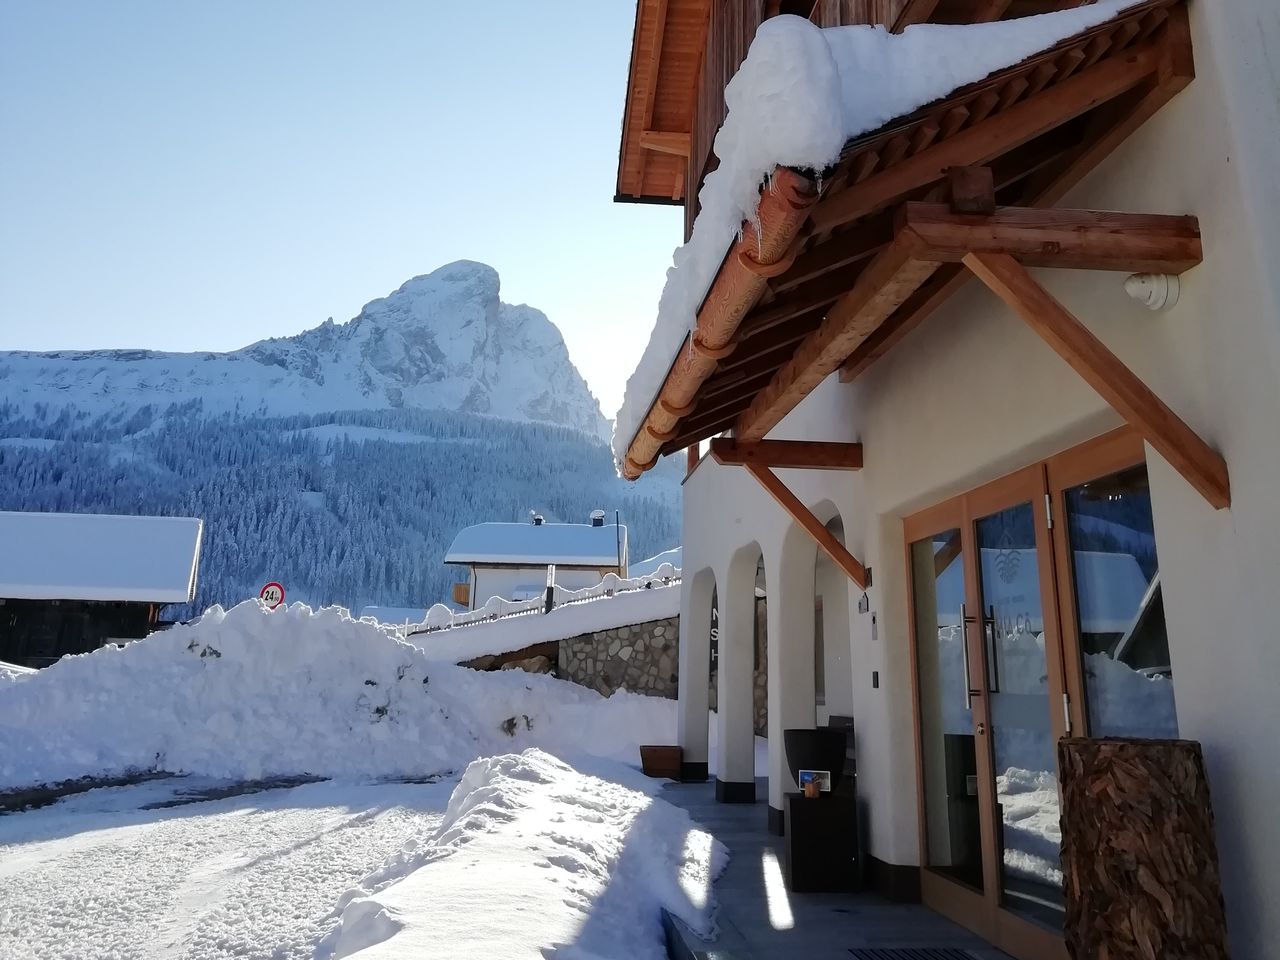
left=964, top=253, right=1231, bottom=509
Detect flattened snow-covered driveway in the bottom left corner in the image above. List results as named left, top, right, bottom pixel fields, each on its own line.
left=0, top=781, right=453, bottom=960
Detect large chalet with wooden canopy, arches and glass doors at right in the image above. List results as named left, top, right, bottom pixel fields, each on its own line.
left=604, top=0, right=1280, bottom=960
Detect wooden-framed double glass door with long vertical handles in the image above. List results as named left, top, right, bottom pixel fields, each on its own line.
left=906, top=465, right=1066, bottom=960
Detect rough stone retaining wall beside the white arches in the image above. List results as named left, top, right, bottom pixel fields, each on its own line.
left=556, top=617, right=680, bottom=700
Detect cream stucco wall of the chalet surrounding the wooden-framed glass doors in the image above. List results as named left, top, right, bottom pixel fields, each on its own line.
left=684, top=0, right=1280, bottom=957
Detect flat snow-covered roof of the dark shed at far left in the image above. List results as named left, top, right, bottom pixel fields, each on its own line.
left=0, top=512, right=204, bottom=603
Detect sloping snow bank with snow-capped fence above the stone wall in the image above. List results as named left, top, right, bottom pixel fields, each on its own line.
left=408, top=573, right=680, bottom=663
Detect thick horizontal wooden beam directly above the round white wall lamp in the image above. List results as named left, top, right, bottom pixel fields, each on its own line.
left=897, top=204, right=1203, bottom=274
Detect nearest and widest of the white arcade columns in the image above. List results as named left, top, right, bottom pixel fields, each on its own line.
left=764, top=530, right=815, bottom=810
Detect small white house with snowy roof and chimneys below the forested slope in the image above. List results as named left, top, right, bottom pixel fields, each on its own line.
left=444, top=509, right=627, bottom=609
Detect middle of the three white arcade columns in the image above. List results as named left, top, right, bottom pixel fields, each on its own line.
left=716, top=550, right=759, bottom=790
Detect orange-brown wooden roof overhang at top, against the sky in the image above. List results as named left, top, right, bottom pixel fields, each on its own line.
left=614, top=0, right=710, bottom=204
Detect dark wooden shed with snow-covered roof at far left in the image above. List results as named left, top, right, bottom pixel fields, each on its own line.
left=0, top=512, right=204, bottom=667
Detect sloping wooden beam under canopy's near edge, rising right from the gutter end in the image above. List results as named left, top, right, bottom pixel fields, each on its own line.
left=810, top=47, right=1160, bottom=233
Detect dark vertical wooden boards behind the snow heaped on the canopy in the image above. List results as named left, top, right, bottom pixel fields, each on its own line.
left=685, top=0, right=908, bottom=239
